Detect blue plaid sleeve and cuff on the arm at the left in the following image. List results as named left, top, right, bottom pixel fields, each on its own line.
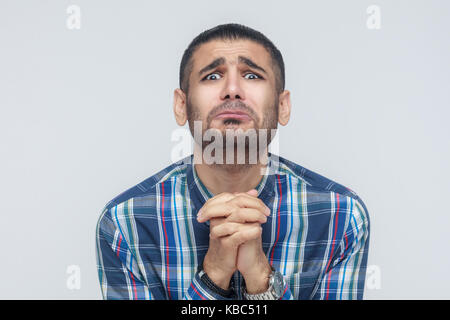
left=96, top=209, right=236, bottom=300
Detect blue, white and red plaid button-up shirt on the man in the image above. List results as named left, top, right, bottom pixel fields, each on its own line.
left=96, top=153, right=369, bottom=300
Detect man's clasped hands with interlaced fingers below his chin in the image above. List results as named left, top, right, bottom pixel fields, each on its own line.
left=197, top=189, right=271, bottom=294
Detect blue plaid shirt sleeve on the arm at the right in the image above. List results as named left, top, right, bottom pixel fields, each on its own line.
left=312, top=198, right=370, bottom=300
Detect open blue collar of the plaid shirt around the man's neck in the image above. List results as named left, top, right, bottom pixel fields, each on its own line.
left=186, top=152, right=278, bottom=211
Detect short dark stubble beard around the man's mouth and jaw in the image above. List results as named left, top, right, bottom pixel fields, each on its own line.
left=186, top=95, right=279, bottom=173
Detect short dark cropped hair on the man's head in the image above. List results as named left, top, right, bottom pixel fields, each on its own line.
left=179, top=23, right=284, bottom=93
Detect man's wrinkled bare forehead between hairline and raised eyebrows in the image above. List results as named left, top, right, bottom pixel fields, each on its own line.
left=193, top=39, right=271, bottom=70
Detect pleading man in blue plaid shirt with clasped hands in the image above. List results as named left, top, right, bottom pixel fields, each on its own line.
left=96, top=24, right=369, bottom=300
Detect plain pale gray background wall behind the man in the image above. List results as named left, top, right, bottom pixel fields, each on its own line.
left=0, top=0, right=450, bottom=299
